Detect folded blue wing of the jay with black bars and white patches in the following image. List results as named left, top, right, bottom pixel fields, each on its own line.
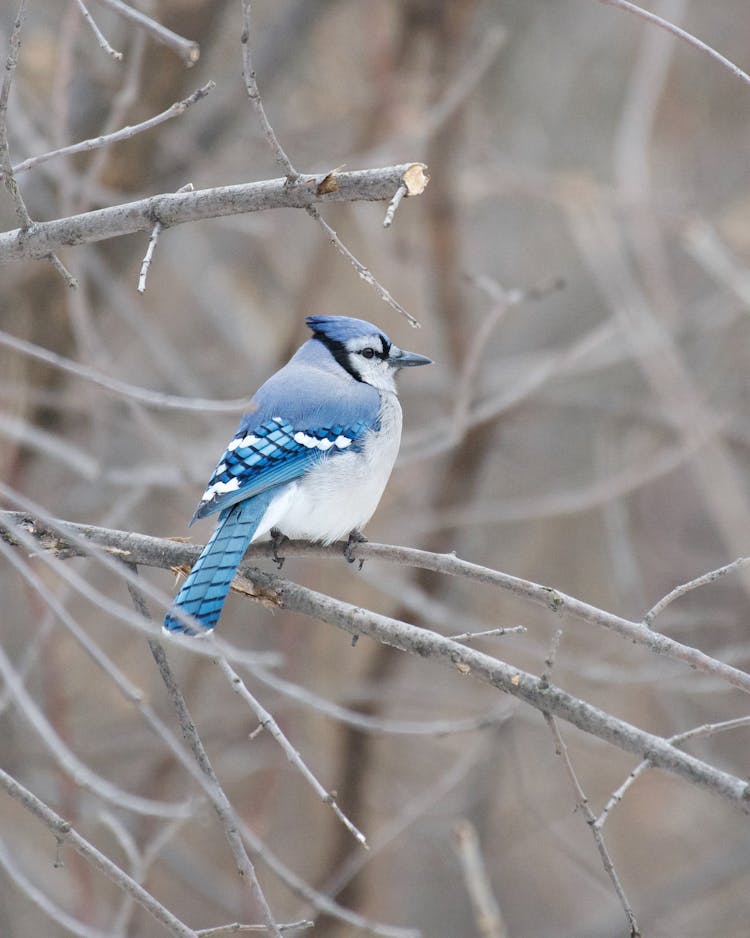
left=191, top=363, right=380, bottom=523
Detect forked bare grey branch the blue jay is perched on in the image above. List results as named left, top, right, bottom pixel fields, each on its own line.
left=2, top=512, right=750, bottom=811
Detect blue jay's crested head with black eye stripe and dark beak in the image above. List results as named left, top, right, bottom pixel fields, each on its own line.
left=305, top=316, right=432, bottom=391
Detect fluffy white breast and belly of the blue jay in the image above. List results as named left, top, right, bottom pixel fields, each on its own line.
left=253, top=393, right=401, bottom=544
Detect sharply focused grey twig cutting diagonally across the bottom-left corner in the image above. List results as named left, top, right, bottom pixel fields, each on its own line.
left=0, top=769, right=197, bottom=938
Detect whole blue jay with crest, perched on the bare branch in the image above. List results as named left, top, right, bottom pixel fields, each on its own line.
left=164, top=316, right=431, bottom=636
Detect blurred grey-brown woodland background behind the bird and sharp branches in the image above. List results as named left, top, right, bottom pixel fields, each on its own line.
left=0, top=0, right=750, bottom=938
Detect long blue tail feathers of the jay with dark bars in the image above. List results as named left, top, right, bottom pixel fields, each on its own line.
left=164, top=492, right=276, bottom=635
